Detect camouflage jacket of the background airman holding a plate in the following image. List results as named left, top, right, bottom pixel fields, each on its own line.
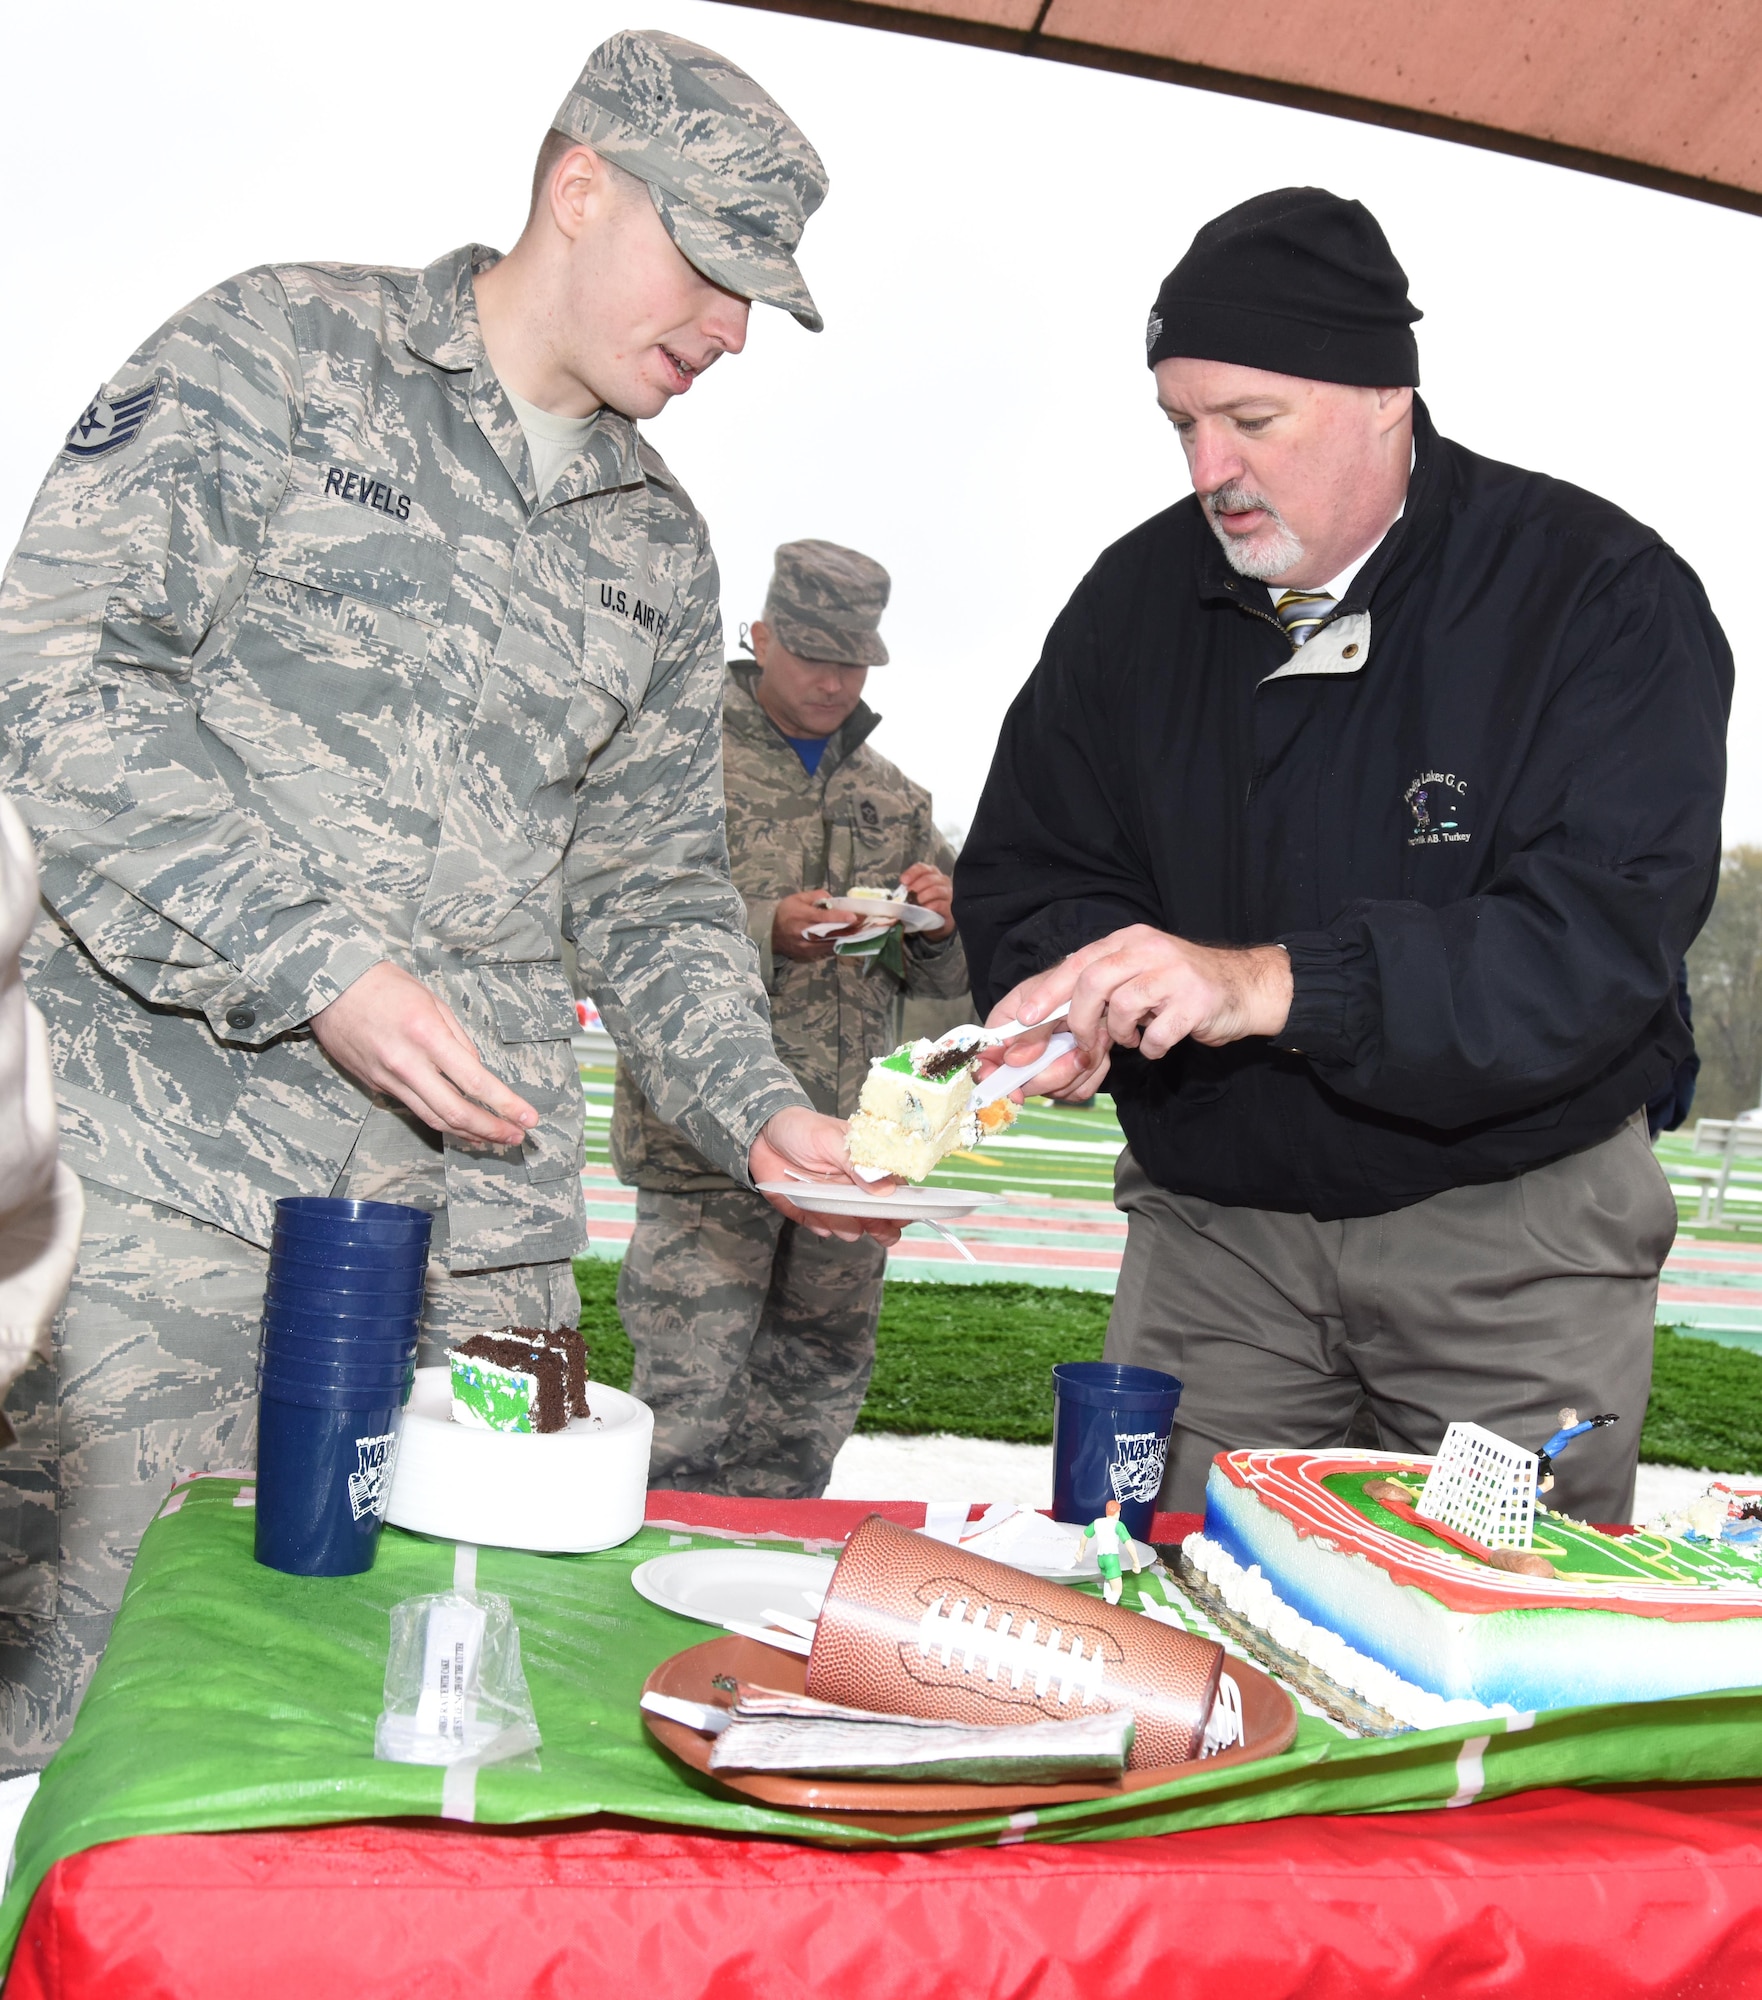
left=612, top=660, right=966, bottom=1192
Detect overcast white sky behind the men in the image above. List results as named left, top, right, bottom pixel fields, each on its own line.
left=0, top=0, right=1762, bottom=842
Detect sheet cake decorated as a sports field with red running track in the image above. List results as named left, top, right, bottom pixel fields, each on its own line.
left=1182, top=1450, right=1762, bottom=1728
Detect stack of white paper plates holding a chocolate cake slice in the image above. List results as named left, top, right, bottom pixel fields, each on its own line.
left=386, top=1368, right=654, bottom=1554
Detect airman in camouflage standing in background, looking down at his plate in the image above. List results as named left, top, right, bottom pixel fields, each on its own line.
left=612, top=542, right=966, bottom=1498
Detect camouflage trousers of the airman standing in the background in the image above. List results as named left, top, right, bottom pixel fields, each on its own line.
left=618, top=1188, right=886, bottom=1500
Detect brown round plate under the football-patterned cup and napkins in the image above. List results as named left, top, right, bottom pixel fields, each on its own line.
left=642, top=1636, right=1298, bottom=1834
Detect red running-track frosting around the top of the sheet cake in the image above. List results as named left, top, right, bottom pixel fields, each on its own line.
left=1216, top=1452, right=1762, bottom=1624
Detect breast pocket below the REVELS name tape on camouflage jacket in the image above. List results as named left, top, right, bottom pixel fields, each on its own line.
left=202, top=510, right=454, bottom=788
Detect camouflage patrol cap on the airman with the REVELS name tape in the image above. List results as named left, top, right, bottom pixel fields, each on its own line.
left=552, top=28, right=826, bottom=334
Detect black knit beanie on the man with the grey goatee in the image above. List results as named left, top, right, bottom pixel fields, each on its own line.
left=1144, top=188, right=1422, bottom=388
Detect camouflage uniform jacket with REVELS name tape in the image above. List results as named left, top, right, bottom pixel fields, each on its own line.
left=0, top=248, right=802, bottom=1270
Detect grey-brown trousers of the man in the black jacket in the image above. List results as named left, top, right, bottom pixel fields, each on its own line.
left=1106, top=1118, right=1676, bottom=1522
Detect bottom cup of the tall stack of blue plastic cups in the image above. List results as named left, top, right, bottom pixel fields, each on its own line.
left=256, top=1388, right=404, bottom=1576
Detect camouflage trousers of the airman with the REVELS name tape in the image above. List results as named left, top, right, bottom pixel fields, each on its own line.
left=0, top=1112, right=580, bottom=1776
